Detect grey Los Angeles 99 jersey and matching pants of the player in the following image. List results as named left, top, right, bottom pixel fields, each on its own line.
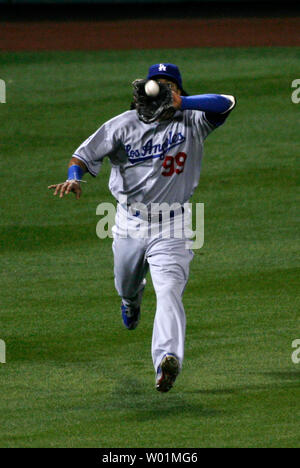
left=73, top=110, right=215, bottom=370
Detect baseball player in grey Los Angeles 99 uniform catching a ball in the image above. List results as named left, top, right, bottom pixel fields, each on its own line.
left=49, top=63, right=235, bottom=392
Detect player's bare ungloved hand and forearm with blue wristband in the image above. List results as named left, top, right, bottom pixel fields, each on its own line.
left=48, top=157, right=87, bottom=200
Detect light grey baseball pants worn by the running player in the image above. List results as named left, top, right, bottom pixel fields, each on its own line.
left=113, top=206, right=193, bottom=370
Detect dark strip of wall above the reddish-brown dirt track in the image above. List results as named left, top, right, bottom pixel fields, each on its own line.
left=0, top=0, right=300, bottom=19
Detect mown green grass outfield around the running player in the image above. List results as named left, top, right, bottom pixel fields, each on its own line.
left=0, top=48, right=300, bottom=448
